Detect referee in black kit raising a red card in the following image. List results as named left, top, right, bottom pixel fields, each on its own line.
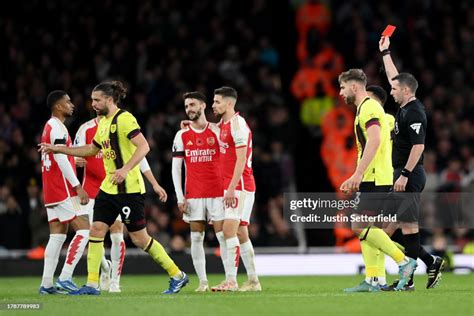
left=379, top=36, right=444, bottom=289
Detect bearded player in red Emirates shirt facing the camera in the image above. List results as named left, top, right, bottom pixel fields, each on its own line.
left=172, top=92, right=226, bottom=292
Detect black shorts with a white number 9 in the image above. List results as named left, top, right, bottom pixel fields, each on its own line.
left=94, top=190, right=146, bottom=232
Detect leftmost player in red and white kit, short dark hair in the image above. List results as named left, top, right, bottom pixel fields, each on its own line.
left=39, top=90, right=89, bottom=294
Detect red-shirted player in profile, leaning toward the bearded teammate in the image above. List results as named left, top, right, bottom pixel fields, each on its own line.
left=212, top=87, right=262, bottom=291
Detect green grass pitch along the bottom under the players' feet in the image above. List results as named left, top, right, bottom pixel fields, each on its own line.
left=0, top=273, right=474, bottom=316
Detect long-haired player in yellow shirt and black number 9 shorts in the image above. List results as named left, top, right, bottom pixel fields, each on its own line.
left=41, top=81, right=189, bottom=295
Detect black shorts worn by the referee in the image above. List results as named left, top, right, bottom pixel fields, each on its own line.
left=392, top=165, right=426, bottom=223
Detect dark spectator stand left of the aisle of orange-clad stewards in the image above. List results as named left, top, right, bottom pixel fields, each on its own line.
left=0, top=1, right=295, bottom=251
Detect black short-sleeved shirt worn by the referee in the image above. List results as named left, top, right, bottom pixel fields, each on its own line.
left=392, top=99, right=427, bottom=169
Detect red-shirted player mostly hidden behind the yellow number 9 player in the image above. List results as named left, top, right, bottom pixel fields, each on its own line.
left=74, top=116, right=167, bottom=293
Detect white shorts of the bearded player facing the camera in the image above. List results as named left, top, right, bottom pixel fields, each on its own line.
left=183, top=197, right=224, bottom=223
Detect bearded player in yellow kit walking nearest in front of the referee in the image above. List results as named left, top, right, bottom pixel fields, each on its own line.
left=339, top=69, right=416, bottom=292
